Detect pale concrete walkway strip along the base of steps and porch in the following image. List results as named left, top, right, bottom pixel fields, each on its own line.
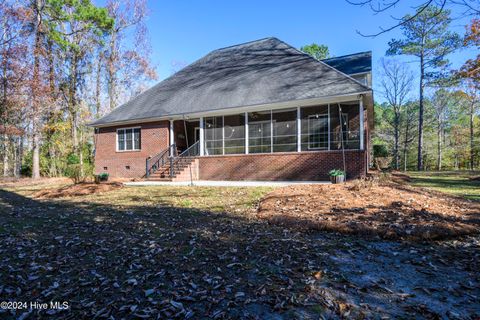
left=123, top=180, right=330, bottom=187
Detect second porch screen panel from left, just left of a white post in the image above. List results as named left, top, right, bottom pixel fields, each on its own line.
left=223, top=114, right=245, bottom=154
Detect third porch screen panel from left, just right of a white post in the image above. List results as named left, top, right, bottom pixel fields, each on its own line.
left=248, top=110, right=272, bottom=153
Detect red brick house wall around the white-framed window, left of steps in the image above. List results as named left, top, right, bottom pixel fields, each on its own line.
left=95, top=121, right=169, bottom=178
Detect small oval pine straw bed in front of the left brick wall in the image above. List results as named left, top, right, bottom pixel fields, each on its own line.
left=34, top=182, right=123, bottom=199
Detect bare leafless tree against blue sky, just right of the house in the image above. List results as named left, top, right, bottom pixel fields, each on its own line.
left=380, top=59, right=413, bottom=170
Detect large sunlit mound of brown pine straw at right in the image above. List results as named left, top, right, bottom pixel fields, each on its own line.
left=258, top=180, right=480, bottom=240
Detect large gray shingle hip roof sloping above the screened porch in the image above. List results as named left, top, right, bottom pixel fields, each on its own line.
left=91, top=38, right=370, bottom=126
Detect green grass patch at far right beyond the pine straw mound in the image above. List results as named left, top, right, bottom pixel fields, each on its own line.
left=408, top=171, right=480, bottom=201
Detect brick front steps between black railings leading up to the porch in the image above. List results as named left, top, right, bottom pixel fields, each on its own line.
left=146, top=157, right=198, bottom=182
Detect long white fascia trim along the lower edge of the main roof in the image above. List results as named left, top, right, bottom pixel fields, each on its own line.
left=88, top=90, right=372, bottom=128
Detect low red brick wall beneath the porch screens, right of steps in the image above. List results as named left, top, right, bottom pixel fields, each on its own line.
left=199, top=150, right=367, bottom=180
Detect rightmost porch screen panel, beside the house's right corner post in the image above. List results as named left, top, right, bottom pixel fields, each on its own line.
left=330, top=102, right=360, bottom=150
